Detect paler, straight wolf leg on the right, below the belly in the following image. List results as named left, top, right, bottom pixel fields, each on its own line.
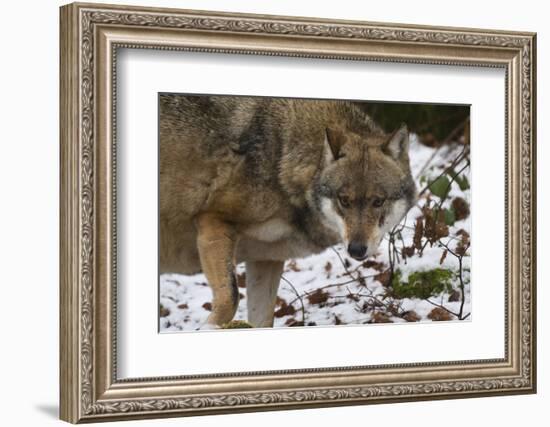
left=246, top=261, right=284, bottom=328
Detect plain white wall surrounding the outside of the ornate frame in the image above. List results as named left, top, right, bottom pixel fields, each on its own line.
left=0, top=0, right=550, bottom=427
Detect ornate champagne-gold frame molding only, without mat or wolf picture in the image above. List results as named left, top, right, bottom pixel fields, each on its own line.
left=60, top=4, right=536, bottom=423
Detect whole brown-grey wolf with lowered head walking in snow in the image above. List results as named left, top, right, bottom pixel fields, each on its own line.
left=159, top=94, right=416, bottom=328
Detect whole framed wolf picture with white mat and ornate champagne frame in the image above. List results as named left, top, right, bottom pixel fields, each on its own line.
left=60, top=3, right=536, bottom=423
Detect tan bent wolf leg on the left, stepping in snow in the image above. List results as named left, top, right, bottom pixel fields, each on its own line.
left=195, top=214, right=239, bottom=326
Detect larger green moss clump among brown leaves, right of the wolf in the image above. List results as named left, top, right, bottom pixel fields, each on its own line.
left=392, top=268, right=454, bottom=299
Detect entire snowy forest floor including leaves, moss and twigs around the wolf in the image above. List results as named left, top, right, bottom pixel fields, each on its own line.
left=160, top=135, right=471, bottom=332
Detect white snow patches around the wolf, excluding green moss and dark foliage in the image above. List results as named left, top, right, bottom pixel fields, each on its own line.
left=160, top=138, right=471, bottom=332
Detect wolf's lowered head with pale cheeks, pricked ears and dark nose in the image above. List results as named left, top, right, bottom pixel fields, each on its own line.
left=319, top=125, right=416, bottom=260
